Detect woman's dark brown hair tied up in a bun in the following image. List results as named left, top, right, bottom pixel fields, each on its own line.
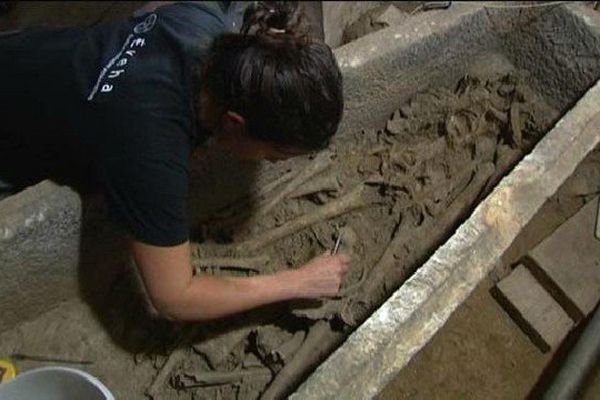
left=204, top=1, right=343, bottom=150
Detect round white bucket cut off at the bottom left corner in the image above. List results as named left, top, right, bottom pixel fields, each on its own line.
left=0, top=367, right=114, bottom=400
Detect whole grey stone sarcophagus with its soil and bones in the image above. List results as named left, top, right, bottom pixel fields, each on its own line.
left=0, top=5, right=600, bottom=399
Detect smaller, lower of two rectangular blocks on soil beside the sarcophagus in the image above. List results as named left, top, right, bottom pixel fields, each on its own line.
left=492, top=265, right=574, bottom=352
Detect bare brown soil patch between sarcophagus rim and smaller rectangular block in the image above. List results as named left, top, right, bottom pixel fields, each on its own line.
left=379, top=280, right=551, bottom=400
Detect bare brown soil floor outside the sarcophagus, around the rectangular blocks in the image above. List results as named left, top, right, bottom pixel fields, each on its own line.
left=379, top=148, right=600, bottom=400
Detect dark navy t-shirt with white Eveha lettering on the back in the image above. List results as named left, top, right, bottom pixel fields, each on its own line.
left=0, top=2, right=226, bottom=246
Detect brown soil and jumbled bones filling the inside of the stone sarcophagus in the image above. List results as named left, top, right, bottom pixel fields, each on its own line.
left=0, top=3, right=588, bottom=400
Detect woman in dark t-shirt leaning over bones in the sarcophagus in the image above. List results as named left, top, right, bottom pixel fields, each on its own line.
left=0, top=2, right=350, bottom=320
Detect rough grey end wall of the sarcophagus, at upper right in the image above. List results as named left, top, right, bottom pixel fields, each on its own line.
left=487, top=3, right=600, bottom=109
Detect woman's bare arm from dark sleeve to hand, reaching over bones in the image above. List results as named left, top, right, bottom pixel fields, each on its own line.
left=132, top=241, right=349, bottom=320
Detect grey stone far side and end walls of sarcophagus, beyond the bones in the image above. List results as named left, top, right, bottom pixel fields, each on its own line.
left=335, top=4, right=600, bottom=140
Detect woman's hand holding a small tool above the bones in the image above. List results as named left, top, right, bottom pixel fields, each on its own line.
left=290, top=253, right=350, bottom=299
